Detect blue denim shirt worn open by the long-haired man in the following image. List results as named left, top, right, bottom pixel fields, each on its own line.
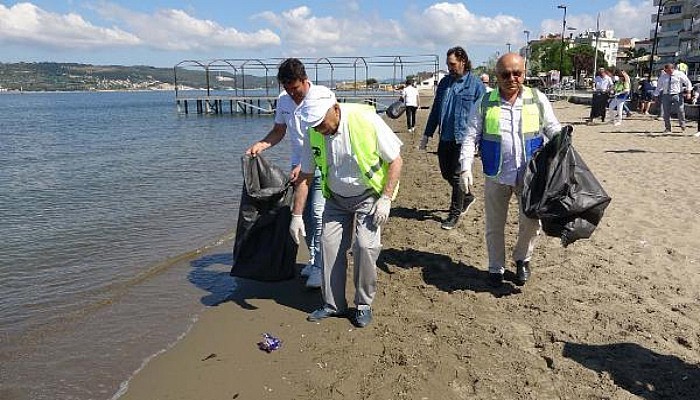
left=423, top=71, right=485, bottom=143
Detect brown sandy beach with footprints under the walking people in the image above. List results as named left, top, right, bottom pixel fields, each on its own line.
left=121, top=101, right=700, bottom=400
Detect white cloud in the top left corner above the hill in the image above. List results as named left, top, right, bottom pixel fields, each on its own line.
left=0, top=3, right=141, bottom=49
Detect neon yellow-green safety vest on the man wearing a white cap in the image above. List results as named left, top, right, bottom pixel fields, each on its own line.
left=309, top=103, right=399, bottom=200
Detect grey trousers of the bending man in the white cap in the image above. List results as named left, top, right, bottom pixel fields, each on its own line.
left=321, top=191, right=382, bottom=312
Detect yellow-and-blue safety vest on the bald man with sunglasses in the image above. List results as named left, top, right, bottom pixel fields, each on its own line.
left=481, top=86, right=544, bottom=178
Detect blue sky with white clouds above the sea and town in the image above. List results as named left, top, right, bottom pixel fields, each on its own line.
left=0, top=0, right=656, bottom=67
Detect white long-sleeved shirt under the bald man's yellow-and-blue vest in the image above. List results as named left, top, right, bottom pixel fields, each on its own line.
left=459, top=86, right=561, bottom=186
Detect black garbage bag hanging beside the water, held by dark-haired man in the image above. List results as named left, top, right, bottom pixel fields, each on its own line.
left=231, top=155, right=297, bottom=281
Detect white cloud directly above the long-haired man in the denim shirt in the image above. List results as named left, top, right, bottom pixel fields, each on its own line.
left=406, top=3, right=524, bottom=48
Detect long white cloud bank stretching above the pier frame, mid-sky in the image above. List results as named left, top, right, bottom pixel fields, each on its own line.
left=256, top=1, right=523, bottom=56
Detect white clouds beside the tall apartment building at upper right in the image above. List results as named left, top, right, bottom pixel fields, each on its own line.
left=540, top=0, right=656, bottom=39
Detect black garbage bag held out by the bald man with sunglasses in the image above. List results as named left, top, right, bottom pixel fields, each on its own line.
left=521, top=126, right=611, bottom=247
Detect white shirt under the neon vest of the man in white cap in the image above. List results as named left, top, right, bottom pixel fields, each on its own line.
left=301, top=109, right=403, bottom=197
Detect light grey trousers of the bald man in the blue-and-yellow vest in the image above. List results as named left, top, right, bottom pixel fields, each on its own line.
left=484, top=178, right=540, bottom=274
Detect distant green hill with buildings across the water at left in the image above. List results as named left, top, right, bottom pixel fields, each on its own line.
left=0, top=62, right=277, bottom=91
